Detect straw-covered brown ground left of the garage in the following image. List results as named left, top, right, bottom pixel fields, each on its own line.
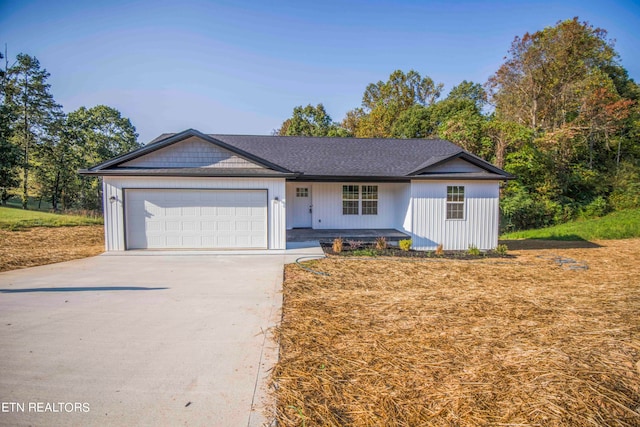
left=0, top=225, right=104, bottom=271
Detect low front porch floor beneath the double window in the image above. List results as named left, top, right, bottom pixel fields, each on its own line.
left=287, top=228, right=411, bottom=243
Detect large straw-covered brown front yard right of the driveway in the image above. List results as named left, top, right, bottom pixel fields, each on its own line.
left=273, top=239, right=640, bottom=426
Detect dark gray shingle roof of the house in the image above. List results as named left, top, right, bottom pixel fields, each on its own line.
left=80, top=129, right=513, bottom=180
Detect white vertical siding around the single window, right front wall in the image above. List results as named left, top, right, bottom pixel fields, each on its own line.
left=411, top=181, right=499, bottom=250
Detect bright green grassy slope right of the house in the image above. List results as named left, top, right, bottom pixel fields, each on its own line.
left=501, top=209, right=640, bottom=240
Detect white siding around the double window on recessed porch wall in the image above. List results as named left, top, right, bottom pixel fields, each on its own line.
left=287, top=182, right=410, bottom=230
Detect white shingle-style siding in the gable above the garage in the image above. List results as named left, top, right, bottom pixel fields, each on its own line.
left=121, top=137, right=262, bottom=169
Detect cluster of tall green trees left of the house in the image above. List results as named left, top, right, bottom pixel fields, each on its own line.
left=0, top=53, right=140, bottom=211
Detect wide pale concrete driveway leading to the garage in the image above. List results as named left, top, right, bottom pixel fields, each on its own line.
left=0, top=254, right=284, bottom=426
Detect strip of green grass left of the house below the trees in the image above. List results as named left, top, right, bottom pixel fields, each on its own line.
left=0, top=207, right=102, bottom=230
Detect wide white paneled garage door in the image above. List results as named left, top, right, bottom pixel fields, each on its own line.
left=125, top=189, right=267, bottom=249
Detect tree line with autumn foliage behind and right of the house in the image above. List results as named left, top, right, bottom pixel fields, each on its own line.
left=274, top=18, right=640, bottom=229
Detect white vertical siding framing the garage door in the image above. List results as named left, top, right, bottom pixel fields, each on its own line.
left=103, top=177, right=287, bottom=251
